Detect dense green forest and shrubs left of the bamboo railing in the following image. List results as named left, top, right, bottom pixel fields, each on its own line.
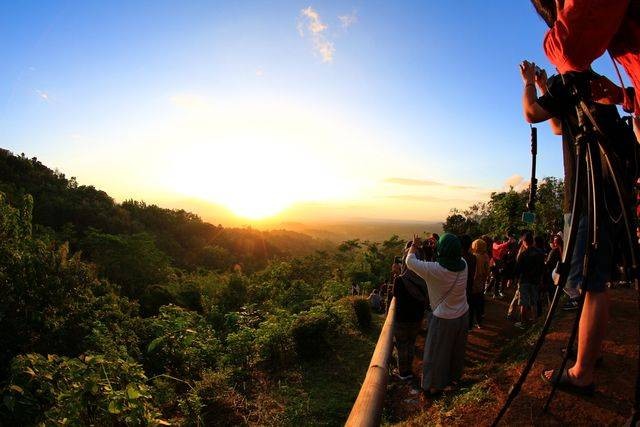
left=0, top=152, right=402, bottom=425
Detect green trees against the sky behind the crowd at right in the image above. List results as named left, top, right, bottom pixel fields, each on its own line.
left=442, top=178, right=564, bottom=237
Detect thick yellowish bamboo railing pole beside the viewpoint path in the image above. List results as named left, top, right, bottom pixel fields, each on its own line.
left=346, top=298, right=396, bottom=427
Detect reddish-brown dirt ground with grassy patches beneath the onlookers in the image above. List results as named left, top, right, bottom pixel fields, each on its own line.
left=385, top=289, right=639, bottom=426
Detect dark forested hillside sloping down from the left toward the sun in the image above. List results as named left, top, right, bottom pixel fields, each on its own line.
left=0, top=149, right=330, bottom=271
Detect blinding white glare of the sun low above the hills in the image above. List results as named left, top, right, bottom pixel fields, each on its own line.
left=161, top=111, right=356, bottom=220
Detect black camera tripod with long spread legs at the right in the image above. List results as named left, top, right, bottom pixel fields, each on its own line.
left=493, top=76, right=640, bottom=426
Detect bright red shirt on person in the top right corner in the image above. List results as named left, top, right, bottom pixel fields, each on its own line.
left=544, top=0, right=640, bottom=114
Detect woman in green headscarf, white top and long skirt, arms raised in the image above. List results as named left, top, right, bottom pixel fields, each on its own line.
left=406, top=233, right=469, bottom=395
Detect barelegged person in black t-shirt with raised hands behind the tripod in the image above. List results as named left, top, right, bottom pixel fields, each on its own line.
left=520, top=53, right=624, bottom=395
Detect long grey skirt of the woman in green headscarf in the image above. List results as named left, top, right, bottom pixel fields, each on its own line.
left=422, top=311, right=469, bottom=390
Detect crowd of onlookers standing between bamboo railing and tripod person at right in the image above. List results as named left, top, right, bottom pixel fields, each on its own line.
left=369, top=231, right=571, bottom=395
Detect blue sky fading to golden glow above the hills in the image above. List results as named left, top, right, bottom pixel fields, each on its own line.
left=0, top=0, right=614, bottom=224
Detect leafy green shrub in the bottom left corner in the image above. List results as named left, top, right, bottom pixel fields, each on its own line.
left=2, top=354, right=164, bottom=425
